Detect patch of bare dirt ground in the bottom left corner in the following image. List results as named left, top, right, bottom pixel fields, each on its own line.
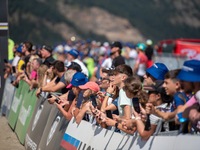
left=0, top=117, right=25, bottom=150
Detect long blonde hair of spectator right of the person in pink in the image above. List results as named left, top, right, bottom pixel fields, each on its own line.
left=37, top=65, right=54, bottom=88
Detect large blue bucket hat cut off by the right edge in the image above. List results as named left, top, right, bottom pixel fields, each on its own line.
left=177, top=60, right=200, bottom=82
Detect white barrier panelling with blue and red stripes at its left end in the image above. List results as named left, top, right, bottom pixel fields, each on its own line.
left=61, top=118, right=200, bottom=150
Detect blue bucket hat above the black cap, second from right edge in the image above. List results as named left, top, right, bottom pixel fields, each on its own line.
left=146, top=63, right=169, bottom=80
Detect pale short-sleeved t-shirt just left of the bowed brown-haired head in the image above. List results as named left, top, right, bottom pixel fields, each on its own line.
left=118, top=88, right=133, bottom=117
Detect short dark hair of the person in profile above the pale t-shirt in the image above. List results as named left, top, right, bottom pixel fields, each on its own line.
left=113, top=64, right=133, bottom=77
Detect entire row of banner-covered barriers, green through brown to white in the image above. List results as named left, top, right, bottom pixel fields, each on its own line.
left=1, top=81, right=200, bottom=150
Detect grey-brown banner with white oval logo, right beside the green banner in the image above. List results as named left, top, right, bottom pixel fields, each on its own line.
left=25, top=97, right=53, bottom=150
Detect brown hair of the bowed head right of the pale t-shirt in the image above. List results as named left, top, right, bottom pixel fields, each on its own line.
left=123, top=76, right=148, bottom=108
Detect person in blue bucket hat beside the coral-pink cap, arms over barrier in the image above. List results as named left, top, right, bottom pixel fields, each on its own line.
left=54, top=72, right=88, bottom=120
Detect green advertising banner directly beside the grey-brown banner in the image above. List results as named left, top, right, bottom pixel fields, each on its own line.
left=15, top=87, right=37, bottom=144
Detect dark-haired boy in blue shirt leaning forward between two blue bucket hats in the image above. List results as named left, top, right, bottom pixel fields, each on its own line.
left=148, top=69, right=188, bottom=121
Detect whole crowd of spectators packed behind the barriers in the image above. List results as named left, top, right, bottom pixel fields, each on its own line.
left=4, top=40, right=200, bottom=140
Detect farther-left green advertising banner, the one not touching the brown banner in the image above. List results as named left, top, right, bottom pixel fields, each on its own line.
left=8, top=80, right=29, bottom=130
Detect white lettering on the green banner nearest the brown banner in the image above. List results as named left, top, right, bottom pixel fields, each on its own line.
left=19, top=104, right=32, bottom=126
